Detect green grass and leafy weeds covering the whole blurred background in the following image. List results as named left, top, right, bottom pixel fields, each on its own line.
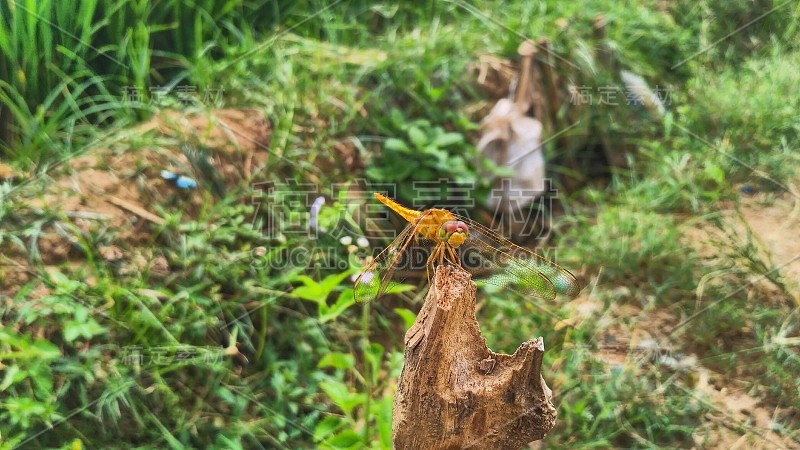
left=0, top=1, right=800, bottom=448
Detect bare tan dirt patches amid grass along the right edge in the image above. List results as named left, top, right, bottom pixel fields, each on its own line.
left=570, top=188, right=800, bottom=449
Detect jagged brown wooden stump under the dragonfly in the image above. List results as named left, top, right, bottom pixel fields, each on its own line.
left=392, top=266, right=556, bottom=450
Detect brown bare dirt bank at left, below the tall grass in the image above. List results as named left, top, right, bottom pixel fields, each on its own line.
left=0, top=109, right=271, bottom=295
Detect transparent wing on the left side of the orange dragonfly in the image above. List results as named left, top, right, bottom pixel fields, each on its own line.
left=353, top=224, right=414, bottom=303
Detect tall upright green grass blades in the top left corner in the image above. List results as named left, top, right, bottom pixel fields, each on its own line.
left=0, top=0, right=300, bottom=169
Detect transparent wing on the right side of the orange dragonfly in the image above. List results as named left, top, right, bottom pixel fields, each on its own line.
left=459, top=217, right=581, bottom=300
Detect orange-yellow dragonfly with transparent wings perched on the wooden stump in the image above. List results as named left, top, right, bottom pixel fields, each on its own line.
left=354, top=192, right=581, bottom=303
